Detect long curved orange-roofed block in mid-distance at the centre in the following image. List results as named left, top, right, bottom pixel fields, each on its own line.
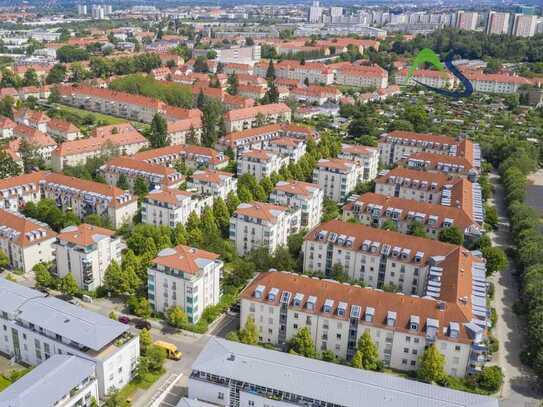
left=217, top=123, right=319, bottom=157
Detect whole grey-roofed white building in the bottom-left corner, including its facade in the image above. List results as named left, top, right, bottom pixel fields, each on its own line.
left=0, top=355, right=99, bottom=407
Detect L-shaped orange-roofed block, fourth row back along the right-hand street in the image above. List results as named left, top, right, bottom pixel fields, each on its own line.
left=375, top=167, right=484, bottom=223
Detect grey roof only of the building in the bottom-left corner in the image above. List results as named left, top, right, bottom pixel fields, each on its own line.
left=0, top=355, right=94, bottom=407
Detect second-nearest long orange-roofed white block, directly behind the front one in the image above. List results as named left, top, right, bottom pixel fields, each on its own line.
left=302, top=220, right=474, bottom=296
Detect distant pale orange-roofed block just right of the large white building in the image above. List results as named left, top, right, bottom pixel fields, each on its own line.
left=254, top=60, right=334, bottom=85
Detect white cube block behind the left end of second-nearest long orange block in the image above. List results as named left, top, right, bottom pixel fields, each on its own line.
left=270, top=181, right=324, bottom=229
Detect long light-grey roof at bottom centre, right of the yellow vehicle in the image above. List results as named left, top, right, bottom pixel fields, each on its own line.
left=192, top=337, right=498, bottom=407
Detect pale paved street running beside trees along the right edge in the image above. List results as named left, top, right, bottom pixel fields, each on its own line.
left=490, top=173, right=543, bottom=407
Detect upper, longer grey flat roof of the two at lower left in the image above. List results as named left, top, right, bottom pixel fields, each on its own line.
left=0, top=278, right=129, bottom=351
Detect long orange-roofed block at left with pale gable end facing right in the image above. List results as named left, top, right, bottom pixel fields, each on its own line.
left=40, top=172, right=138, bottom=229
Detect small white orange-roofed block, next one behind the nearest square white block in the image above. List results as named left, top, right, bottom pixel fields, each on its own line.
left=141, top=188, right=213, bottom=227
